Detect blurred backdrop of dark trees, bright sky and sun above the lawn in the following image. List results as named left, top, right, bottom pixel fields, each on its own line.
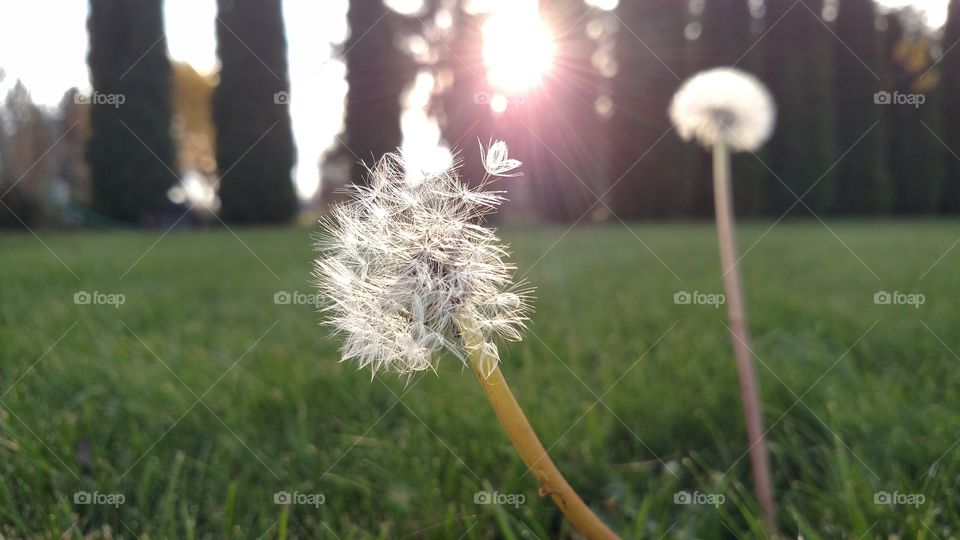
left=0, top=0, right=960, bottom=228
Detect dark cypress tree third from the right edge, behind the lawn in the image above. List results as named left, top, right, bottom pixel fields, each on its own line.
left=834, top=0, right=892, bottom=214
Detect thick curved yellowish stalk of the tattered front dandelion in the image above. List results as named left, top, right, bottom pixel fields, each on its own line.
left=458, top=321, right=618, bottom=540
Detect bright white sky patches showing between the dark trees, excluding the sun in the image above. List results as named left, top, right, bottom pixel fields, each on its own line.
left=0, top=0, right=948, bottom=195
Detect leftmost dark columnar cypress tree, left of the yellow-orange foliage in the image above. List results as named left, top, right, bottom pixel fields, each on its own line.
left=86, top=0, right=176, bottom=224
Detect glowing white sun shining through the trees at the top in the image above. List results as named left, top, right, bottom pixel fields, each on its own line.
left=482, top=2, right=556, bottom=95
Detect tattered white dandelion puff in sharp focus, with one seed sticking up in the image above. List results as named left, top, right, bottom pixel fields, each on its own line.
left=314, top=142, right=529, bottom=375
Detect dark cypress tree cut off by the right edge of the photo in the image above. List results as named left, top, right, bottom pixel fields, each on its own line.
left=940, top=0, right=960, bottom=213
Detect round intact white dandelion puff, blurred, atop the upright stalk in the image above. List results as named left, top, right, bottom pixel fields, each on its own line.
left=670, top=67, right=776, bottom=152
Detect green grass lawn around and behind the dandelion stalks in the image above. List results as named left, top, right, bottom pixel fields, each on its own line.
left=0, top=222, right=960, bottom=538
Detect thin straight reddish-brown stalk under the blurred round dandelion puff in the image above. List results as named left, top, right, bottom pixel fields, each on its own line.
left=713, top=142, right=777, bottom=533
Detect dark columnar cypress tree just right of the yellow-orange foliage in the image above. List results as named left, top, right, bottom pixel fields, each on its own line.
left=213, top=0, right=296, bottom=223
